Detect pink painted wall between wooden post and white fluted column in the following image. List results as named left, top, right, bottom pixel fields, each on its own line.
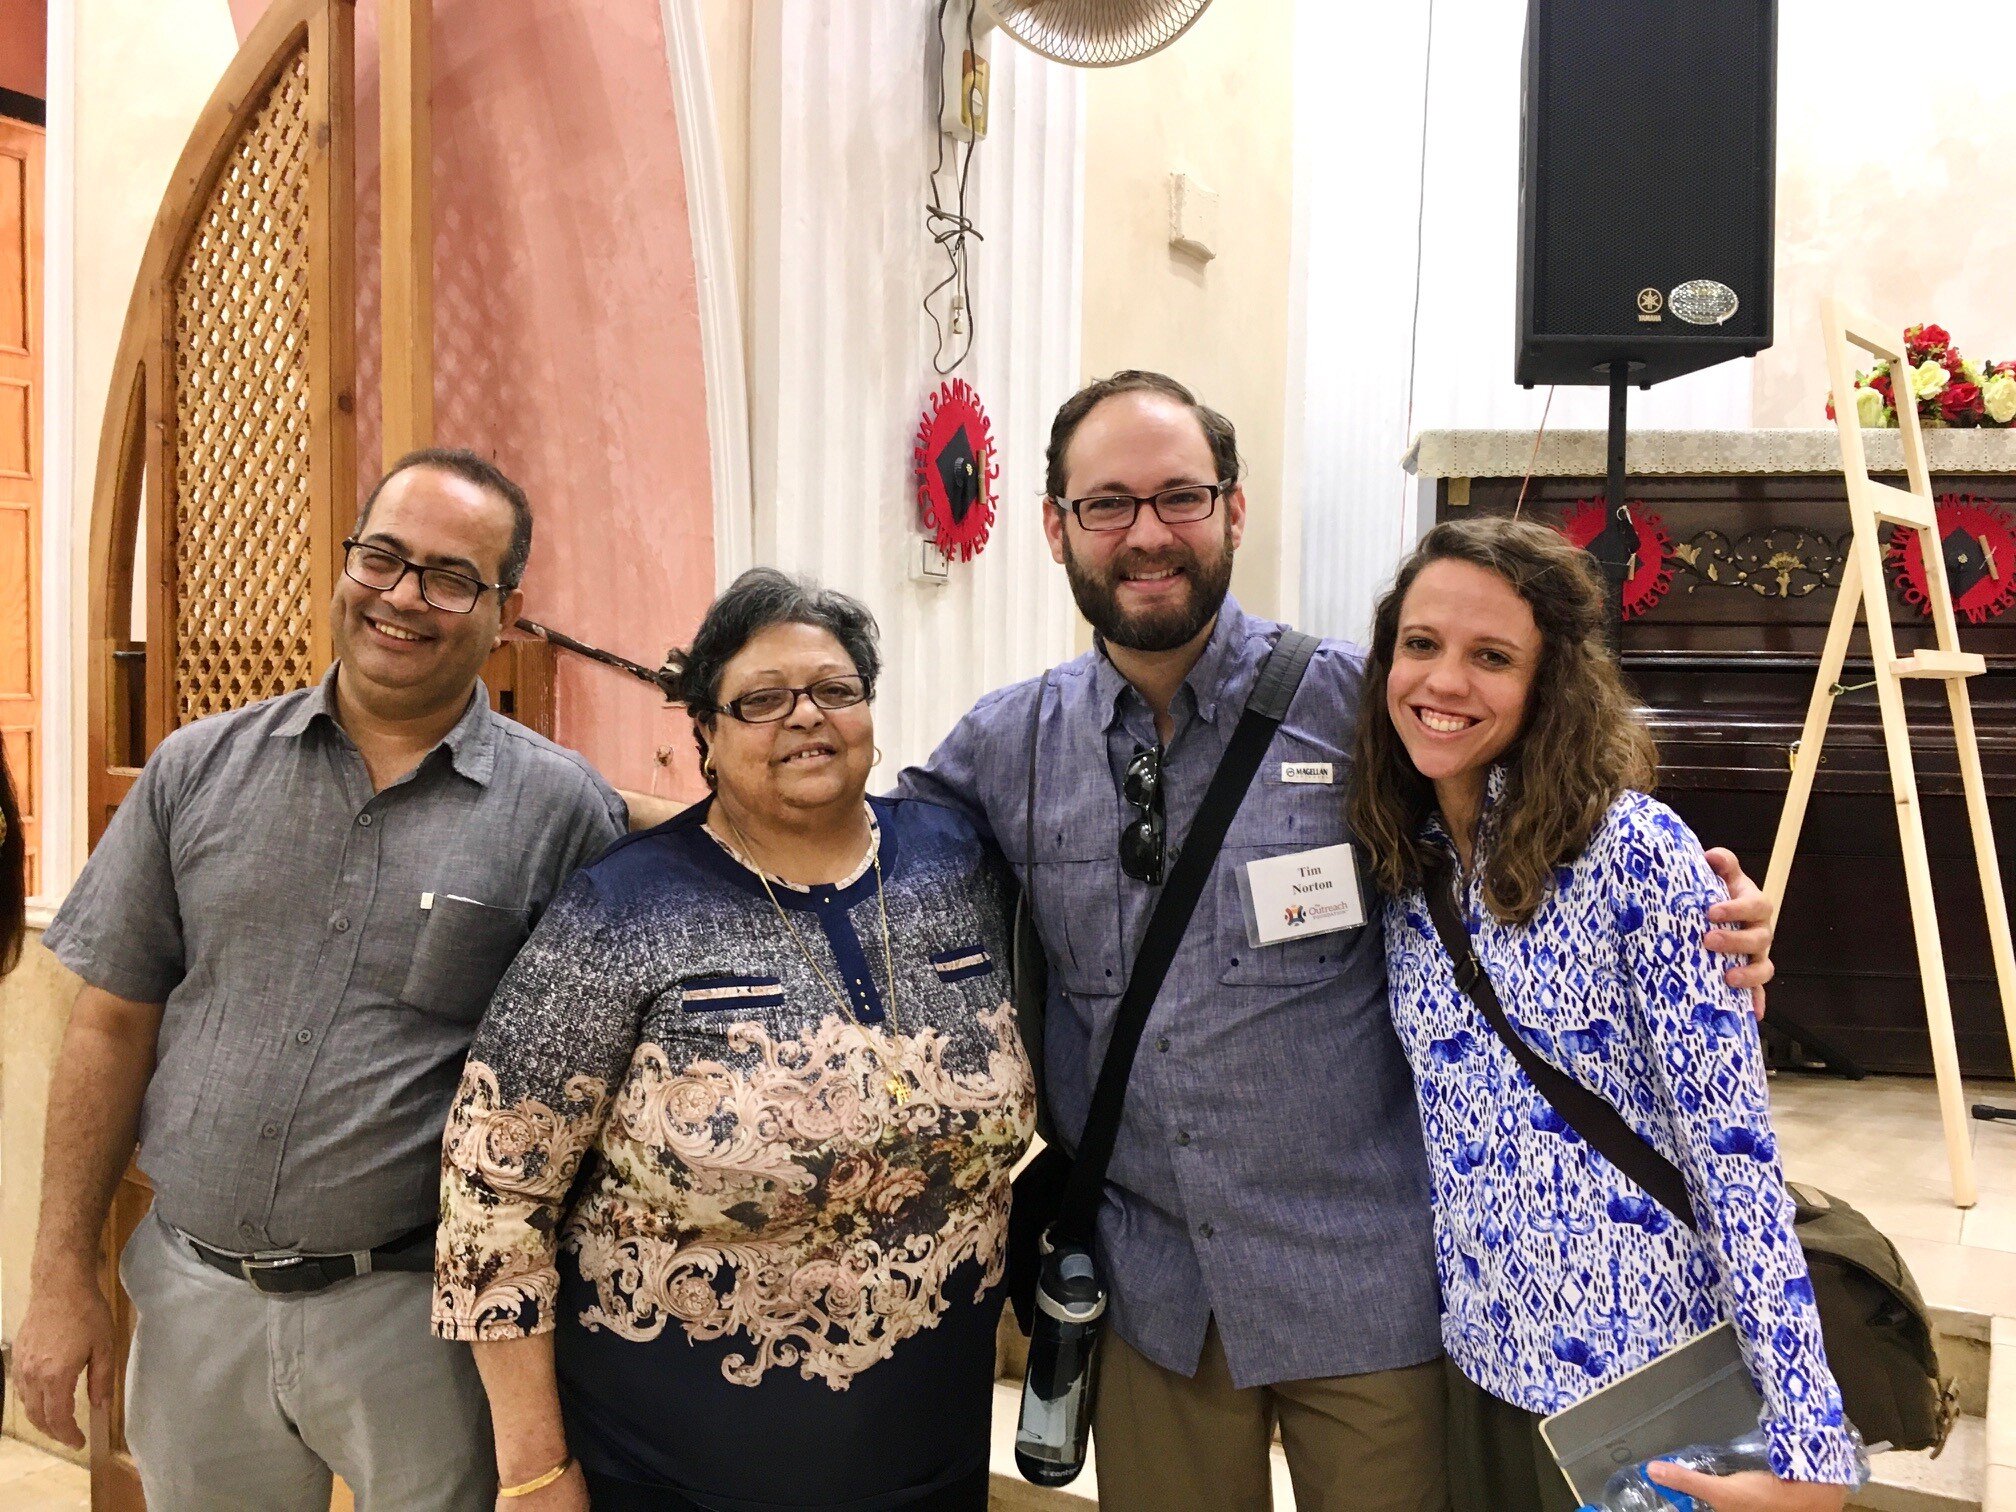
left=230, top=0, right=714, bottom=796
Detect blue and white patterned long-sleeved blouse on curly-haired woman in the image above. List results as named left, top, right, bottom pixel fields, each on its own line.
left=1385, top=772, right=1855, bottom=1484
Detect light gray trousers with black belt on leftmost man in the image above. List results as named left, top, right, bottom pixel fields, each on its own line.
left=119, top=1218, right=496, bottom=1512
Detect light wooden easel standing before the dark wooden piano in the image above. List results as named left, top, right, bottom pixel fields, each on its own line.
left=1764, top=298, right=2016, bottom=1208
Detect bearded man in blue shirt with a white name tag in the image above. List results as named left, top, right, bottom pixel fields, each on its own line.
left=903, top=373, right=1768, bottom=1512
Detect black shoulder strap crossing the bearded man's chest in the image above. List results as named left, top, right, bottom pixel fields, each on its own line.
left=1054, top=629, right=1316, bottom=1244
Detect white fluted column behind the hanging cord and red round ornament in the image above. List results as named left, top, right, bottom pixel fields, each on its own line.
left=750, top=0, right=1083, bottom=780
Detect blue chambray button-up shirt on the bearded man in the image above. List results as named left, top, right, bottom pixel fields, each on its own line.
left=899, top=599, right=1441, bottom=1387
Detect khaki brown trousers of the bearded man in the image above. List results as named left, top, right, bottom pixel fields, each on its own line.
left=1093, top=1322, right=1450, bottom=1512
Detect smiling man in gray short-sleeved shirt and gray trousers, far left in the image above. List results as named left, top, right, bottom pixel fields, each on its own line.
left=18, top=452, right=625, bottom=1512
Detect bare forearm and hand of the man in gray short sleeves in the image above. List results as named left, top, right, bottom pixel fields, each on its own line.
left=14, top=986, right=161, bottom=1450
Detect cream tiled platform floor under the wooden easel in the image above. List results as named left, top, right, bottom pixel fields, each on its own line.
left=1772, top=1073, right=2016, bottom=1316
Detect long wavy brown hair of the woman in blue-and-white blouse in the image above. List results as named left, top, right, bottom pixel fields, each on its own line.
left=1351, top=516, right=1659, bottom=923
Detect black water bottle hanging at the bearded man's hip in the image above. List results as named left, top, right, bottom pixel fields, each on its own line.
left=1014, top=1238, right=1107, bottom=1486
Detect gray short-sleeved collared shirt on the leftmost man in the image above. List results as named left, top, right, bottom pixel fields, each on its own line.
left=44, top=669, right=625, bottom=1254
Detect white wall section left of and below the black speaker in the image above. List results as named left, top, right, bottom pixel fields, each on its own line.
left=1290, top=0, right=1752, bottom=637
